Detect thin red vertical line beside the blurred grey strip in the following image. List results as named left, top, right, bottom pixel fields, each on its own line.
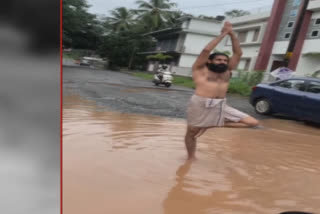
left=60, top=0, right=63, bottom=214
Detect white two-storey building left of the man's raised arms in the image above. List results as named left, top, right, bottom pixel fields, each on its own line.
left=144, top=17, right=223, bottom=76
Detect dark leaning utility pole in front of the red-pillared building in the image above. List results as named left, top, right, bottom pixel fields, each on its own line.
left=284, top=0, right=309, bottom=67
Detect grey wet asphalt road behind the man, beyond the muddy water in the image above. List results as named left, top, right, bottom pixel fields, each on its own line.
left=63, top=66, right=267, bottom=119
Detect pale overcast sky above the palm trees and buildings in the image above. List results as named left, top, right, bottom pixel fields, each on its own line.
left=87, top=0, right=274, bottom=16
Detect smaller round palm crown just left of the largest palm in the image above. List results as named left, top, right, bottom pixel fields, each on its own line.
left=107, top=7, right=134, bottom=32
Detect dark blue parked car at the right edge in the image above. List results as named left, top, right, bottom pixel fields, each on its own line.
left=250, top=77, right=320, bottom=123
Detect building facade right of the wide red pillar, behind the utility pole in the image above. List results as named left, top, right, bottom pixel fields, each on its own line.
left=266, top=0, right=320, bottom=77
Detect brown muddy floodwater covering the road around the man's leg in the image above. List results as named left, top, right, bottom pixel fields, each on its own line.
left=63, top=95, right=320, bottom=214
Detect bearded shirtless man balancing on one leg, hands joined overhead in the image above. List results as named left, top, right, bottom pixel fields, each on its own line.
left=185, top=22, right=259, bottom=159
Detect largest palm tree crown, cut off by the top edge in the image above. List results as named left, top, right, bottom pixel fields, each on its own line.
left=134, top=0, right=176, bottom=31
